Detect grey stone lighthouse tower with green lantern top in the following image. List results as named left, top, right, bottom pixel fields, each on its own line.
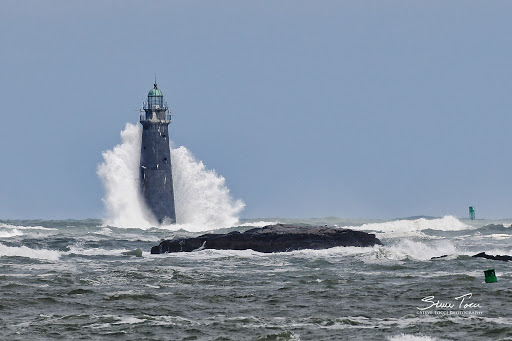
left=139, top=80, right=176, bottom=224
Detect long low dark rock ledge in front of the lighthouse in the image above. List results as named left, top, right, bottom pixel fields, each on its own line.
left=151, top=224, right=382, bottom=254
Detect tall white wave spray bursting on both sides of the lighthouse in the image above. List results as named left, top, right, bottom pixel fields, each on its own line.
left=97, top=123, right=245, bottom=231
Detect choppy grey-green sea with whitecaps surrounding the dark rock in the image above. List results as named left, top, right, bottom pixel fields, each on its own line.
left=0, top=217, right=512, bottom=340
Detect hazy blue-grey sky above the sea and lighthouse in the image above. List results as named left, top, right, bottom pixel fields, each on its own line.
left=0, top=0, right=512, bottom=219
